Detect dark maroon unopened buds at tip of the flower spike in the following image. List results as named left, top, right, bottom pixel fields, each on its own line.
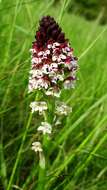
left=36, top=16, right=66, bottom=48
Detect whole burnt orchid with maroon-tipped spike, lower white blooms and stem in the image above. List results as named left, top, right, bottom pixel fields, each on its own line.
left=28, top=16, right=78, bottom=190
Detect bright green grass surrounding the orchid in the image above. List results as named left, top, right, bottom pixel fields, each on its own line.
left=0, top=0, right=107, bottom=190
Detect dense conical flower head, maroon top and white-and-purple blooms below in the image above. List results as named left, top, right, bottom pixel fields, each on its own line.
left=28, top=16, right=77, bottom=96
